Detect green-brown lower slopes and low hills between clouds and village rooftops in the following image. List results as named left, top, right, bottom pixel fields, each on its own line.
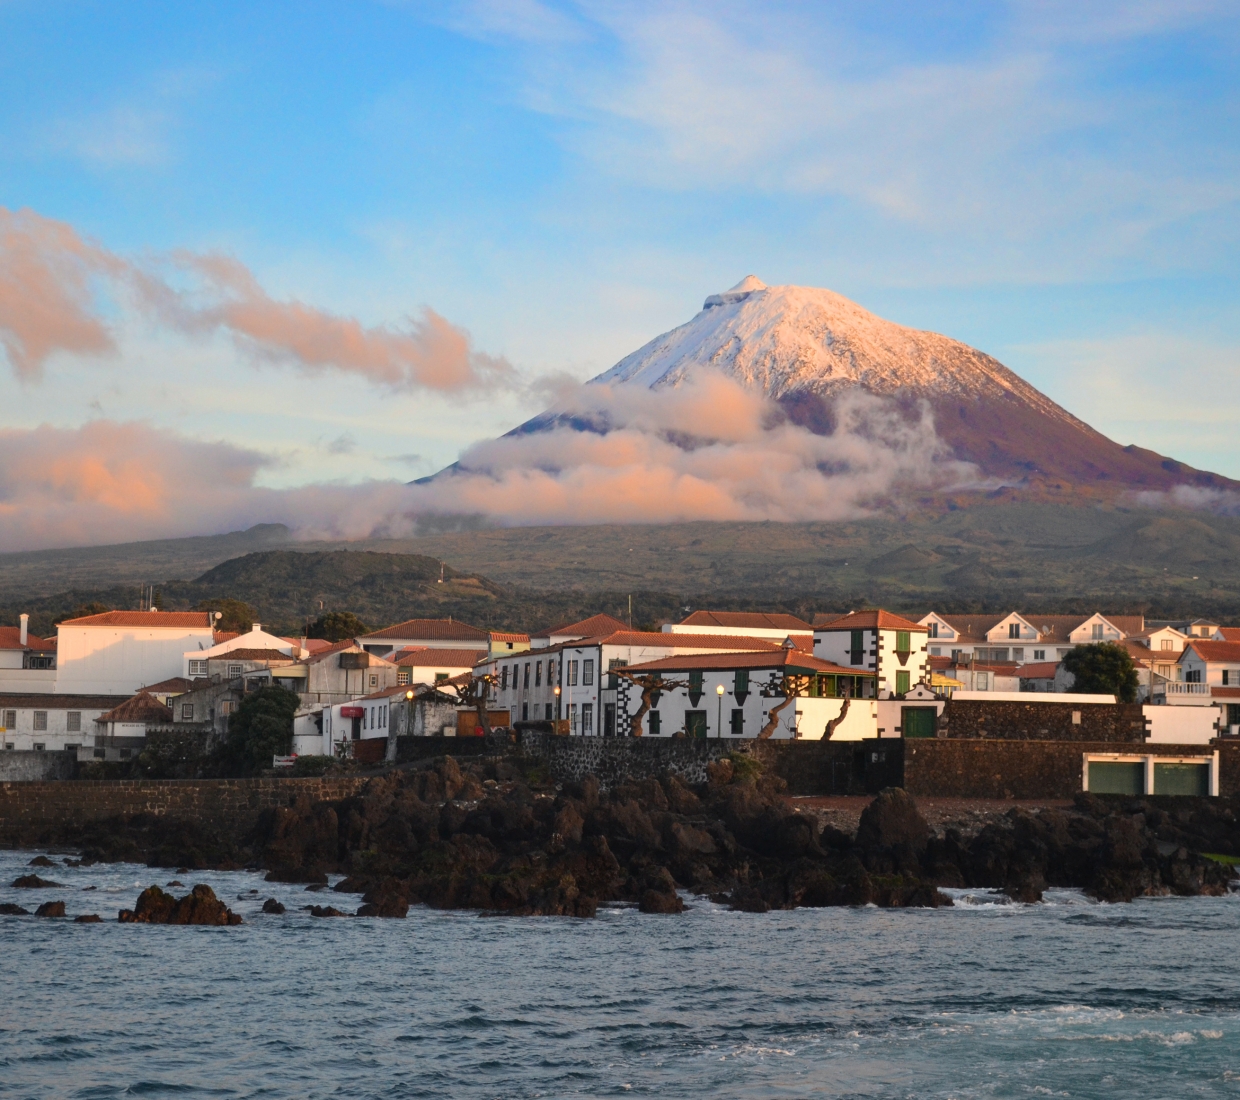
left=0, top=502, right=1240, bottom=629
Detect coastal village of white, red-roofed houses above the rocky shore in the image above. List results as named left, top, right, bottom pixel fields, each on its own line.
left=0, top=609, right=1240, bottom=794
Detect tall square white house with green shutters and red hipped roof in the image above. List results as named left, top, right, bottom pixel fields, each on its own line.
left=813, top=609, right=929, bottom=698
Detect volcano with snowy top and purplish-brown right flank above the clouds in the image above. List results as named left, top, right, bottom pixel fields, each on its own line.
left=510, top=275, right=1240, bottom=496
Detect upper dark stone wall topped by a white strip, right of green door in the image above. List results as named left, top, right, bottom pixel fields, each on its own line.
left=939, top=692, right=1146, bottom=744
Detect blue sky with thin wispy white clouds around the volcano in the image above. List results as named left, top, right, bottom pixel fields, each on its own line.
left=0, top=0, right=1240, bottom=548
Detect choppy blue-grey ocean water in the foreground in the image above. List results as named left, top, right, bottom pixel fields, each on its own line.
left=0, top=852, right=1240, bottom=1098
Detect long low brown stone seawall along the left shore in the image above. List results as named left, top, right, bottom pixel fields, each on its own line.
left=0, top=773, right=367, bottom=843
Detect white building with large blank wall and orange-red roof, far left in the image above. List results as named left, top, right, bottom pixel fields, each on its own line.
left=56, top=611, right=215, bottom=696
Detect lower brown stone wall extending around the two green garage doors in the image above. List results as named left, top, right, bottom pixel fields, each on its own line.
left=904, top=738, right=1220, bottom=799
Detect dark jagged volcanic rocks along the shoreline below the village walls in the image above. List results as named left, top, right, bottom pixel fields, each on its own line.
left=14, top=756, right=1240, bottom=924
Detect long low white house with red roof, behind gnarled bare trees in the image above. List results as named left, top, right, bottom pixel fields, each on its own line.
left=615, top=646, right=878, bottom=740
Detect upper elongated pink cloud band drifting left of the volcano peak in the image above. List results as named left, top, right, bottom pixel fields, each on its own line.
left=0, top=208, right=517, bottom=392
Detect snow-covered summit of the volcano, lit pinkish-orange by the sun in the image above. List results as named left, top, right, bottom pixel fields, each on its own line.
left=594, top=275, right=1084, bottom=427
